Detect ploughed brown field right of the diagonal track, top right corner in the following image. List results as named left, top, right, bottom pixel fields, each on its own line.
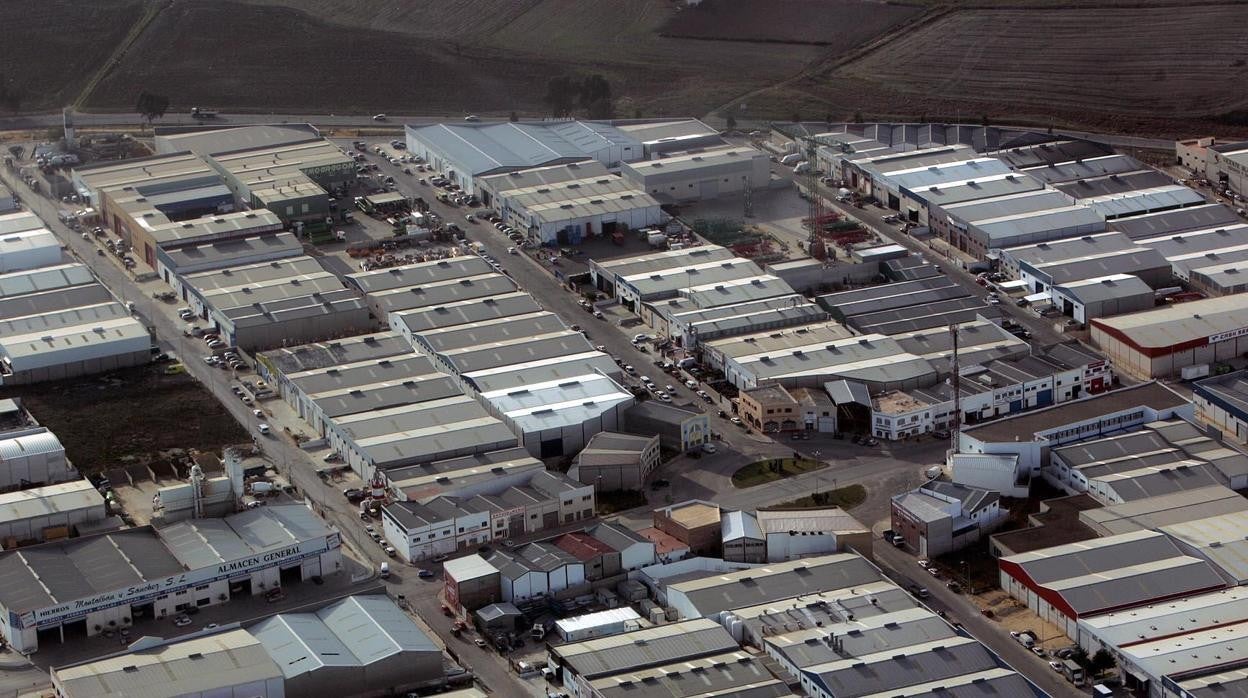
left=755, top=4, right=1248, bottom=136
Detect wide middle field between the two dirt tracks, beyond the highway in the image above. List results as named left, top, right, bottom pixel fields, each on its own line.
left=78, top=0, right=819, bottom=116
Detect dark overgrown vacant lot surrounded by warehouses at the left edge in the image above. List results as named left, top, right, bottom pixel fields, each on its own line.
left=0, top=366, right=248, bottom=473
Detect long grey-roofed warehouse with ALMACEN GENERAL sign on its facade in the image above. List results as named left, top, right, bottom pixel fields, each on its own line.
left=0, top=504, right=342, bottom=653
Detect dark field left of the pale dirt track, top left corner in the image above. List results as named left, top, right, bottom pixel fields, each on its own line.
left=0, top=0, right=144, bottom=111
